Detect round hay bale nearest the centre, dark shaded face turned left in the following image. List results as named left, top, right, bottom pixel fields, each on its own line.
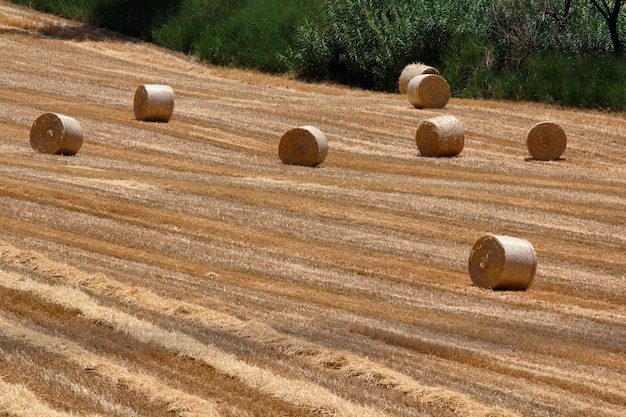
left=278, top=126, right=328, bottom=166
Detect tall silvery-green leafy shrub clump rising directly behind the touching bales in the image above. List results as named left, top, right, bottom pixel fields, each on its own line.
left=286, top=0, right=450, bottom=91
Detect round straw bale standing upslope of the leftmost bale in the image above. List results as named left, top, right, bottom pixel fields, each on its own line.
left=134, top=84, right=174, bottom=122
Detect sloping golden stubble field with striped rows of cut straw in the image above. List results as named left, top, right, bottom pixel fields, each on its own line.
left=0, top=2, right=626, bottom=417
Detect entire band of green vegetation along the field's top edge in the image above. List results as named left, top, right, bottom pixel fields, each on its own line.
left=8, top=0, right=626, bottom=111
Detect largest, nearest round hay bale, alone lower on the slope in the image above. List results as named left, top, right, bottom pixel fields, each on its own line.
left=468, top=235, right=537, bottom=290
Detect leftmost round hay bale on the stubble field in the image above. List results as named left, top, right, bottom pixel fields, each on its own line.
left=30, top=113, right=83, bottom=155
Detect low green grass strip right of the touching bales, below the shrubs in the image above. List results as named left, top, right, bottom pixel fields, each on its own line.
left=439, top=42, right=626, bottom=111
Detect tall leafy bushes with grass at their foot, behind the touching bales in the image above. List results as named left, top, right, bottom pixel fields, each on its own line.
left=286, top=0, right=626, bottom=110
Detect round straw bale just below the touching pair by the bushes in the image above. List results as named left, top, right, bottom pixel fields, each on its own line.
left=415, top=115, right=465, bottom=156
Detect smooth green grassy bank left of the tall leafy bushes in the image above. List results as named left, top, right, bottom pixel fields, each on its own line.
left=8, top=0, right=322, bottom=72
